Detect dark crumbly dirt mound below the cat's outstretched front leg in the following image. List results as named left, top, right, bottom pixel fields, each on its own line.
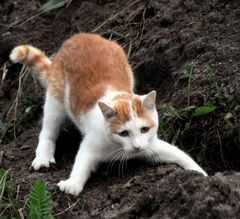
left=116, top=170, right=240, bottom=218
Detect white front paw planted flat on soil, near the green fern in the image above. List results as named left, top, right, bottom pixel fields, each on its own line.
left=57, top=178, right=83, bottom=196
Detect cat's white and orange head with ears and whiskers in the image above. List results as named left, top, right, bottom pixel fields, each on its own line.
left=98, top=91, right=158, bottom=154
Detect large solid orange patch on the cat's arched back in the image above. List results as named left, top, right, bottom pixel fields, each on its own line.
left=53, top=33, right=133, bottom=114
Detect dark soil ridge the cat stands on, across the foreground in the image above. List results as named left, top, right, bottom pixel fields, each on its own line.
left=3, top=129, right=240, bottom=219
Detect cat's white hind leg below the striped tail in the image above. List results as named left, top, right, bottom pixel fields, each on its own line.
left=32, top=92, right=65, bottom=170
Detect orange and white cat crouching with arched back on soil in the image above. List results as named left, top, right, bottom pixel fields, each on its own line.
left=10, top=33, right=207, bottom=196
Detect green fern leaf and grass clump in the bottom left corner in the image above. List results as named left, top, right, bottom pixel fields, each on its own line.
left=0, top=169, right=54, bottom=219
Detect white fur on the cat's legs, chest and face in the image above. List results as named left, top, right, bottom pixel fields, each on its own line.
left=32, top=86, right=207, bottom=195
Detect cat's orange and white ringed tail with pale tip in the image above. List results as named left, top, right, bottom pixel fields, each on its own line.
left=10, top=45, right=51, bottom=87
